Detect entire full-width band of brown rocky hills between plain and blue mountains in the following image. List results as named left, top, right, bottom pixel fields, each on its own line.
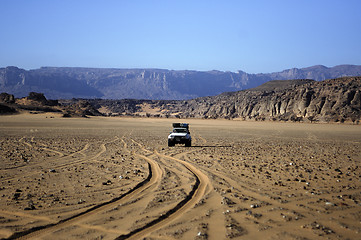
left=0, top=77, right=361, bottom=124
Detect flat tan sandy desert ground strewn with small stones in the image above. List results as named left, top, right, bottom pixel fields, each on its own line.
left=0, top=114, right=361, bottom=239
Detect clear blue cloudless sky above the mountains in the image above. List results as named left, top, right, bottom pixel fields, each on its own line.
left=0, top=0, right=361, bottom=73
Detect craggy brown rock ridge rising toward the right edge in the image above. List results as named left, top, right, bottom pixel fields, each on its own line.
left=169, top=77, right=361, bottom=122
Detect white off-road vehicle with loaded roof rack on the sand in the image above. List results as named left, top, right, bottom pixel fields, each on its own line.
left=168, top=123, right=192, bottom=147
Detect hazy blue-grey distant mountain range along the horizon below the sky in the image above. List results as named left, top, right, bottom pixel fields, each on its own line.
left=0, top=65, right=361, bottom=100
